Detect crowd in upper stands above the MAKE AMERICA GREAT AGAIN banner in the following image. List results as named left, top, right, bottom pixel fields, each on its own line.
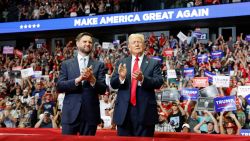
left=0, top=0, right=249, bottom=22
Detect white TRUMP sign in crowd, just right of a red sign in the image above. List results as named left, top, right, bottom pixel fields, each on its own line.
left=213, top=76, right=230, bottom=87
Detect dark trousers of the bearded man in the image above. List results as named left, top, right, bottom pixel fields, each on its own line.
left=62, top=104, right=97, bottom=136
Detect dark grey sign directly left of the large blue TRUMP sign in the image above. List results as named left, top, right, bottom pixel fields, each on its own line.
left=196, top=97, right=214, bottom=111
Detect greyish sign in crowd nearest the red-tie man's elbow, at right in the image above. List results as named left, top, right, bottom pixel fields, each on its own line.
left=161, top=89, right=180, bottom=101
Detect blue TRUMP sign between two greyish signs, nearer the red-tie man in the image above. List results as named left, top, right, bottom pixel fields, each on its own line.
left=181, top=88, right=199, bottom=100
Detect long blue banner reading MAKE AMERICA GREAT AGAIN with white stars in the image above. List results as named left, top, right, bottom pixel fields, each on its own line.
left=0, top=2, right=250, bottom=34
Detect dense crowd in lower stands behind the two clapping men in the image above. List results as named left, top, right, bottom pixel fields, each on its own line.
left=0, top=29, right=250, bottom=135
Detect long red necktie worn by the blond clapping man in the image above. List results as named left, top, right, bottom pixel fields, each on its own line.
left=130, top=56, right=139, bottom=106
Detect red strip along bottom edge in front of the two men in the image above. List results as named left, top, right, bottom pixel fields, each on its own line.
left=0, top=128, right=250, bottom=141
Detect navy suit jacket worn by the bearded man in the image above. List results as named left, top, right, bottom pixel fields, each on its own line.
left=57, top=57, right=106, bottom=125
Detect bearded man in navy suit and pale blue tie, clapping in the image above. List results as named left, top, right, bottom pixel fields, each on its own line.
left=57, top=33, right=106, bottom=135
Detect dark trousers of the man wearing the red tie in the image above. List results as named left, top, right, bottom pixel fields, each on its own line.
left=117, top=104, right=155, bottom=137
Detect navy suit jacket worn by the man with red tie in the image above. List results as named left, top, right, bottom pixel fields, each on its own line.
left=110, top=56, right=163, bottom=125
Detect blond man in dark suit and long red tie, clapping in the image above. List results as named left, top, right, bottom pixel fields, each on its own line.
left=110, top=34, right=163, bottom=137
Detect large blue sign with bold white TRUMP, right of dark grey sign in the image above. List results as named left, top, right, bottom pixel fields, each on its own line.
left=214, top=96, right=236, bottom=112
